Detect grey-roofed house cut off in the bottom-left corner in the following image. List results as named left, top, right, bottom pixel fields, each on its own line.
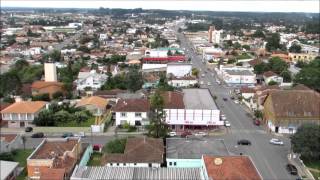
left=0, top=160, right=19, bottom=180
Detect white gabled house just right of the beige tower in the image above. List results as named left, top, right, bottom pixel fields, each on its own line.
left=76, top=70, right=107, bottom=91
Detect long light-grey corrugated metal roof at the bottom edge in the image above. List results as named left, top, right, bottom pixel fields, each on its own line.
left=71, top=166, right=201, bottom=180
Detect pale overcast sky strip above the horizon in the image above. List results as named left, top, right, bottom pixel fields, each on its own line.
left=1, top=0, right=320, bottom=13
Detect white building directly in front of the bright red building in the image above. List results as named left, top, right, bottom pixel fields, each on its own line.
left=167, top=63, right=192, bottom=77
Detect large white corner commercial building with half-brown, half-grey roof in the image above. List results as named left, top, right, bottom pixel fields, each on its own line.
left=162, top=88, right=223, bottom=131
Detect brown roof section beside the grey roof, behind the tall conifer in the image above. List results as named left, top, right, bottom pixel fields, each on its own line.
left=161, top=91, right=184, bottom=109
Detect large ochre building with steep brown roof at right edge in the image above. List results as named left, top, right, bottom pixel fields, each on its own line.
left=264, top=90, right=320, bottom=134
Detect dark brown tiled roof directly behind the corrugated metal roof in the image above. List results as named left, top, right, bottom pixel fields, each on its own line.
left=103, top=137, right=164, bottom=163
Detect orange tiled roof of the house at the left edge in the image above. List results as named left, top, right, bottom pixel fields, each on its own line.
left=1, top=101, right=46, bottom=113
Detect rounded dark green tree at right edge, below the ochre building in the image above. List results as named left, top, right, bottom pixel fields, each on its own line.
left=291, top=124, right=320, bottom=161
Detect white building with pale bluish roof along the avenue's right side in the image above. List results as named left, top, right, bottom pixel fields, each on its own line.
left=216, top=66, right=256, bottom=86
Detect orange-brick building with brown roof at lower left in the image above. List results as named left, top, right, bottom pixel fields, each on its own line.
left=27, top=138, right=81, bottom=179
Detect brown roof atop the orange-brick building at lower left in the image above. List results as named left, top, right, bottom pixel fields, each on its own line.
left=30, top=139, right=78, bottom=159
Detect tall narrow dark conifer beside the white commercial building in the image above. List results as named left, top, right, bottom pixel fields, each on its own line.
left=147, top=90, right=168, bottom=138
